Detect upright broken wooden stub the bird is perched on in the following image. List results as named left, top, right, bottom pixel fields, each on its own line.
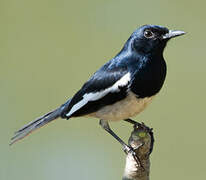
left=122, top=123, right=154, bottom=180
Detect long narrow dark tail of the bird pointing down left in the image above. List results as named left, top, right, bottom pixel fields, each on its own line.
left=10, top=104, right=68, bottom=145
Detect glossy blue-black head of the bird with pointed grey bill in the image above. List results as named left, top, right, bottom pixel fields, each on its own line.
left=128, top=25, right=185, bottom=54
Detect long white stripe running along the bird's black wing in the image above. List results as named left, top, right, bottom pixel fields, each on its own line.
left=66, top=72, right=131, bottom=117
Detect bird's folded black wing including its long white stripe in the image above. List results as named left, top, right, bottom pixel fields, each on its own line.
left=62, top=61, right=129, bottom=118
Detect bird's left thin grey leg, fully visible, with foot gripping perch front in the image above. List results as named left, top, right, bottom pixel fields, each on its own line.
left=99, top=119, right=141, bottom=166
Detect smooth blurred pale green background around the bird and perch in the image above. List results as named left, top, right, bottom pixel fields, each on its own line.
left=0, top=0, right=206, bottom=180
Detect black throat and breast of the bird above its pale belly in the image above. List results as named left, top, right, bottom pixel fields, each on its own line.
left=131, top=53, right=167, bottom=98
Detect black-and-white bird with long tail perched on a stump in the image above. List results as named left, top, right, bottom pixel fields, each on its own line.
left=10, top=25, right=185, bottom=156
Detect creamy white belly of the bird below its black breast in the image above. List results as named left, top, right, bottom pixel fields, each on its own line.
left=89, top=93, right=154, bottom=121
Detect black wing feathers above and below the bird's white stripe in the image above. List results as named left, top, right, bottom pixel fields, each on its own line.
left=62, top=59, right=128, bottom=118
